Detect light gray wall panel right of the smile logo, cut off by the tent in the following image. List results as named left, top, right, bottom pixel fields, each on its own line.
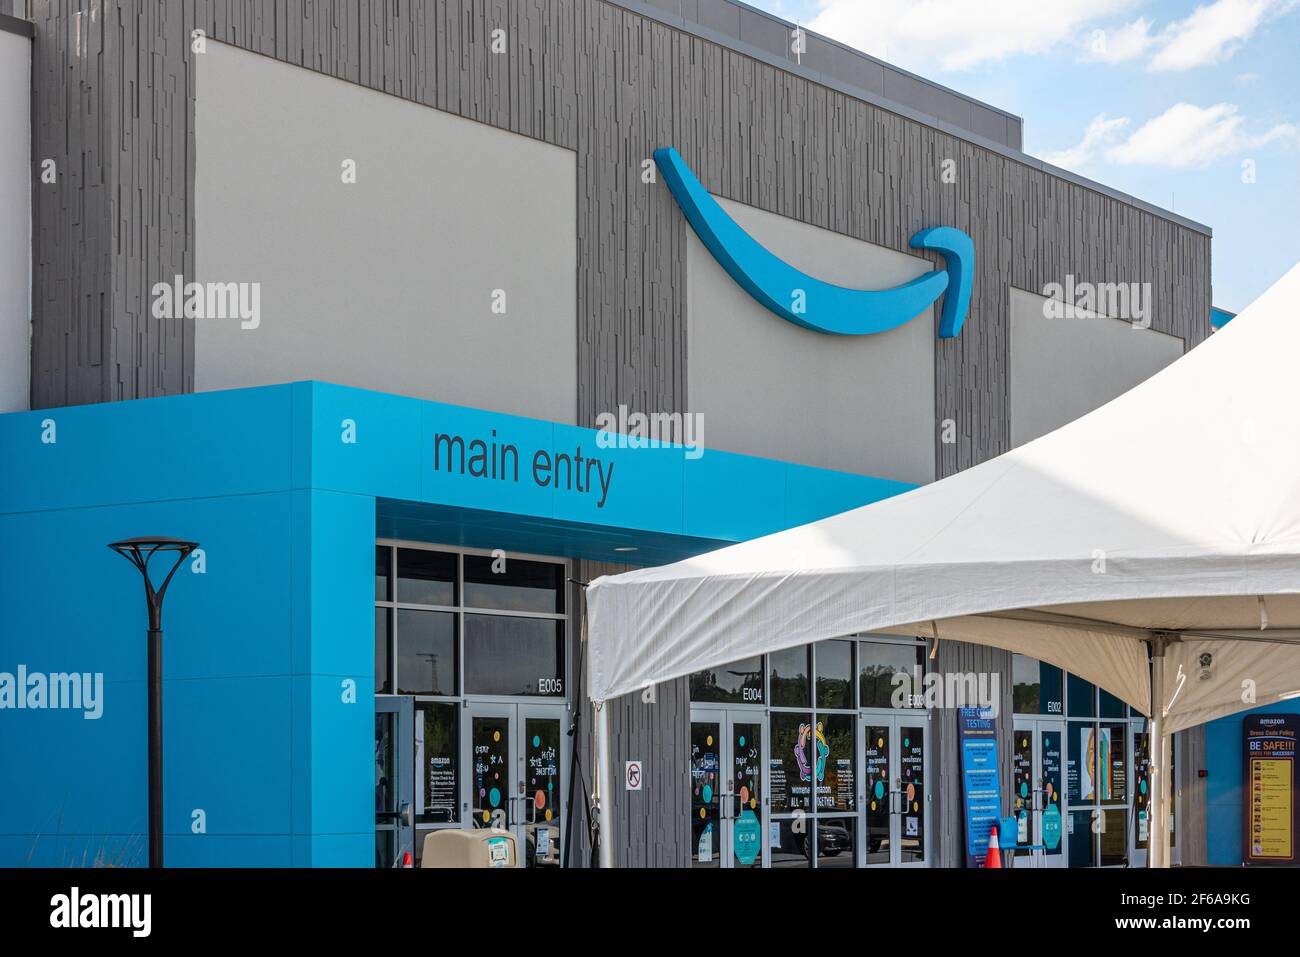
left=1008, top=289, right=1183, bottom=445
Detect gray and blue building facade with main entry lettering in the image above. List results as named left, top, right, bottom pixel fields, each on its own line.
left=0, top=0, right=1268, bottom=866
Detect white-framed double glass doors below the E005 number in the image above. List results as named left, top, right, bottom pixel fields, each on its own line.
left=462, top=702, right=569, bottom=867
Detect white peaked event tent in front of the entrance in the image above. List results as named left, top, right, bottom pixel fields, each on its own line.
left=586, top=267, right=1300, bottom=866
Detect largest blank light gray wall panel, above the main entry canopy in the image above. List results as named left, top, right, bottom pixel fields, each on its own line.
left=195, top=42, right=577, bottom=424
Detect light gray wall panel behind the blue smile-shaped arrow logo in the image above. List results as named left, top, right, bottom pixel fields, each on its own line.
left=686, top=200, right=937, bottom=484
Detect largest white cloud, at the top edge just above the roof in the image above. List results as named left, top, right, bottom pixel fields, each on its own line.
left=807, top=0, right=1132, bottom=75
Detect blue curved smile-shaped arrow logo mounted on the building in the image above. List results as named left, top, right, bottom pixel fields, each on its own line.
left=654, top=147, right=975, bottom=339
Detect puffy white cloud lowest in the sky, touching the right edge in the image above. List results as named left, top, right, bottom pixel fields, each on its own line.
left=1105, top=103, right=1297, bottom=169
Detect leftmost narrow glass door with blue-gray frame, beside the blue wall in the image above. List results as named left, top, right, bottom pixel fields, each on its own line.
left=374, top=694, right=415, bottom=867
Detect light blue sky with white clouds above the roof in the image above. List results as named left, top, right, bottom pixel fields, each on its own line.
left=748, top=0, right=1300, bottom=312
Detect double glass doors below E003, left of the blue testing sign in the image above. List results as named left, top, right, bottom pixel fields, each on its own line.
left=858, top=713, right=931, bottom=867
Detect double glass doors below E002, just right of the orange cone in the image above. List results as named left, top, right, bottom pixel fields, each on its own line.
left=1000, top=718, right=1067, bottom=867
